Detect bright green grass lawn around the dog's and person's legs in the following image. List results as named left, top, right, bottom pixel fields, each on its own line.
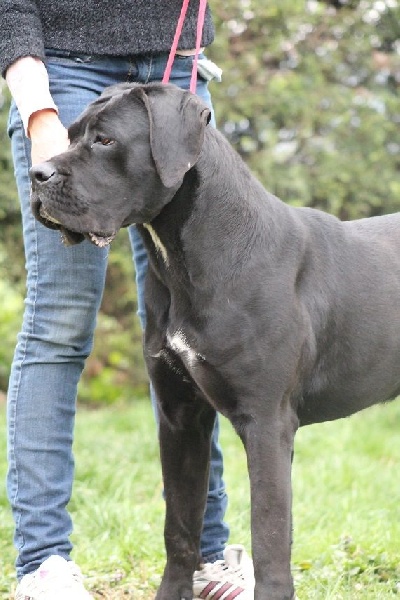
left=0, top=400, right=400, bottom=600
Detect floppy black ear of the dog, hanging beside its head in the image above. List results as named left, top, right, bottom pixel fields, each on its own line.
left=136, top=86, right=211, bottom=188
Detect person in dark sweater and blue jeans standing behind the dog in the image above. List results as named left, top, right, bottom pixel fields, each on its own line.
left=0, top=0, right=253, bottom=600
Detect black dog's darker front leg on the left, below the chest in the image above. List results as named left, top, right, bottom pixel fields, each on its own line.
left=156, top=390, right=215, bottom=600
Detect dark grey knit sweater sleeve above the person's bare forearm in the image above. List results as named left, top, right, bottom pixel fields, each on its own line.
left=0, top=0, right=44, bottom=77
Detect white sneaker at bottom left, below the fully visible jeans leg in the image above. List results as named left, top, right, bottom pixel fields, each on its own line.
left=15, top=555, right=93, bottom=600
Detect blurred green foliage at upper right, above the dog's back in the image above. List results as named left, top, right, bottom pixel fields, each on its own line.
left=211, top=0, right=400, bottom=219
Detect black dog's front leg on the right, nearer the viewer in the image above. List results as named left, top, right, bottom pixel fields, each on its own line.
left=238, top=406, right=297, bottom=600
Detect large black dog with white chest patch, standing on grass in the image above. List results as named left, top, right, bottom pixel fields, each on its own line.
left=31, top=85, right=400, bottom=600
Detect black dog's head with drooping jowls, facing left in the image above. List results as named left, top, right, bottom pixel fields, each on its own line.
left=30, top=84, right=210, bottom=246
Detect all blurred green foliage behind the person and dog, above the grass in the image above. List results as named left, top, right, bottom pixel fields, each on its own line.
left=0, top=0, right=400, bottom=403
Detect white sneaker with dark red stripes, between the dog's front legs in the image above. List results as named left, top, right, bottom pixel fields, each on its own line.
left=193, top=544, right=254, bottom=600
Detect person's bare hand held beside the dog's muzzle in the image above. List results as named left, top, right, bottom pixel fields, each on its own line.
left=28, top=109, right=69, bottom=165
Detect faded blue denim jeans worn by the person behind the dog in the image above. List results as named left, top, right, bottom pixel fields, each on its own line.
left=7, top=51, right=228, bottom=578
